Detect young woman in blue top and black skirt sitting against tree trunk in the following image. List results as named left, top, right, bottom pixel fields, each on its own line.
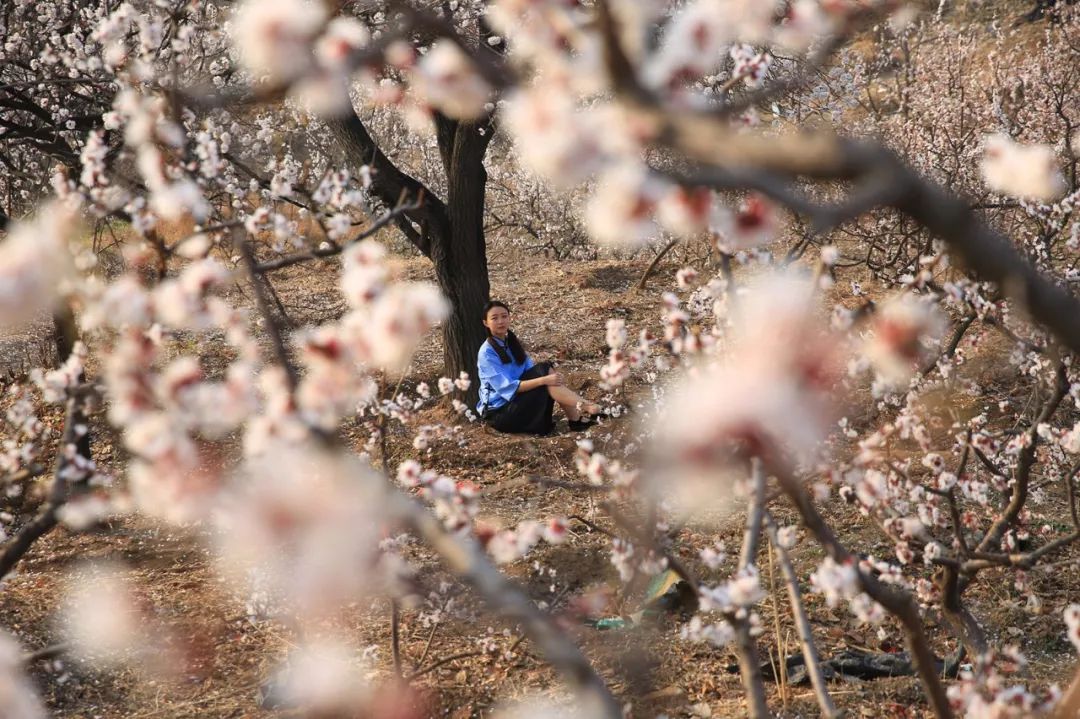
left=476, top=300, right=600, bottom=434
